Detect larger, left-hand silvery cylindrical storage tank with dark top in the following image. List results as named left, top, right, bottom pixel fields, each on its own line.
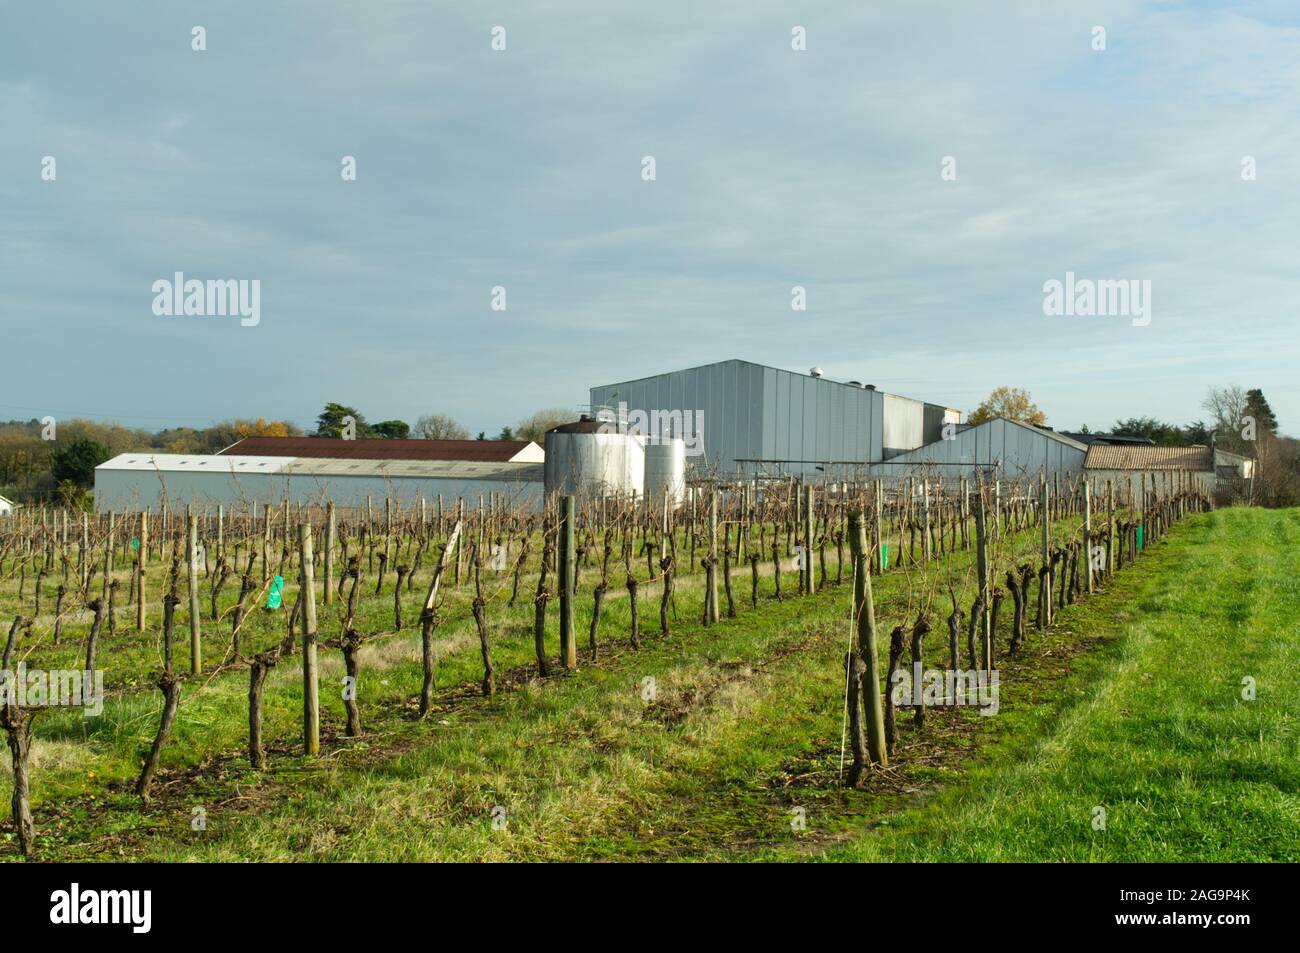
left=543, top=415, right=644, bottom=495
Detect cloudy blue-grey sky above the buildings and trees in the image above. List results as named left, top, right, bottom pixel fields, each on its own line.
left=0, top=0, right=1300, bottom=434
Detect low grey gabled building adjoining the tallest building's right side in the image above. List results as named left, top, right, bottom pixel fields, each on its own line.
left=870, top=417, right=1092, bottom=481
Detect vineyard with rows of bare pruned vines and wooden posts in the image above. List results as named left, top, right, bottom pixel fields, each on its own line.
left=0, top=475, right=1296, bottom=861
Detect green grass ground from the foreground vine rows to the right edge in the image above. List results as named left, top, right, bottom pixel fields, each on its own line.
left=3, top=501, right=1300, bottom=861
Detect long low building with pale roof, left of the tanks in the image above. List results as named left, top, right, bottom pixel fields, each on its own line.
left=95, top=441, right=542, bottom=512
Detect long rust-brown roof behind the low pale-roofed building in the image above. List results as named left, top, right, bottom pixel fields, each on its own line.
left=221, top=437, right=541, bottom=463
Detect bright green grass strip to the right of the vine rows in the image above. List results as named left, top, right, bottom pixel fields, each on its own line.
left=811, top=510, right=1300, bottom=862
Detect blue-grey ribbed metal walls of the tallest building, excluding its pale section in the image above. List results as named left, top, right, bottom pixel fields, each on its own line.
left=592, top=360, right=883, bottom=473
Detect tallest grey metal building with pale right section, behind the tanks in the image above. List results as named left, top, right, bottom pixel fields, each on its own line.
left=590, top=360, right=959, bottom=477
